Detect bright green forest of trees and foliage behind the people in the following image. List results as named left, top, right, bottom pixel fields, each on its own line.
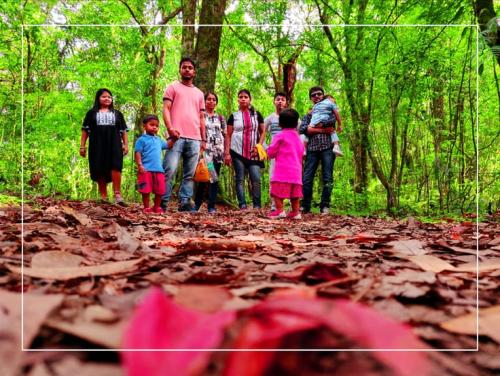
left=0, top=0, right=500, bottom=218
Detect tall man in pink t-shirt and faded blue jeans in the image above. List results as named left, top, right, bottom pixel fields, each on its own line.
left=161, top=57, right=206, bottom=211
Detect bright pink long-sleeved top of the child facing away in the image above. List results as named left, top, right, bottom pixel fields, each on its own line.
left=267, top=128, right=304, bottom=185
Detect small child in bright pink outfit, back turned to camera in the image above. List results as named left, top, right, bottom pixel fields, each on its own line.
left=267, top=109, right=304, bottom=219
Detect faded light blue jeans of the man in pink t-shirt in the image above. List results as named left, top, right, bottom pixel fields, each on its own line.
left=162, top=138, right=200, bottom=206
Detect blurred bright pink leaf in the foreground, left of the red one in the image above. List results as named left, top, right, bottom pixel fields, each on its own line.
left=122, top=289, right=235, bottom=376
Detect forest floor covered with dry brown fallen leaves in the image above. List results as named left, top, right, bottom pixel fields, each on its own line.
left=0, top=198, right=500, bottom=376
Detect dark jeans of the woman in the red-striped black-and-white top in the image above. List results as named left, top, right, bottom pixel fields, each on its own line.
left=231, top=153, right=261, bottom=208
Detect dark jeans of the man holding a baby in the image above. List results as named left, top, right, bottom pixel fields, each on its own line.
left=302, top=149, right=335, bottom=212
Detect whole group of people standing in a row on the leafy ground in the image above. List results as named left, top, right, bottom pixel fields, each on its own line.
left=80, top=57, right=342, bottom=219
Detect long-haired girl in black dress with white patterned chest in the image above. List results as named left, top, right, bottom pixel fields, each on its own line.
left=80, top=89, right=128, bottom=206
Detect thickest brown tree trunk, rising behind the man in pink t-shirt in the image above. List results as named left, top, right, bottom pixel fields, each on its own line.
left=195, top=0, right=226, bottom=92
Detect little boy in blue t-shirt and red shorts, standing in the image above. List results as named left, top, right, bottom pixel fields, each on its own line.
left=134, top=115, right=175, bottom=214
